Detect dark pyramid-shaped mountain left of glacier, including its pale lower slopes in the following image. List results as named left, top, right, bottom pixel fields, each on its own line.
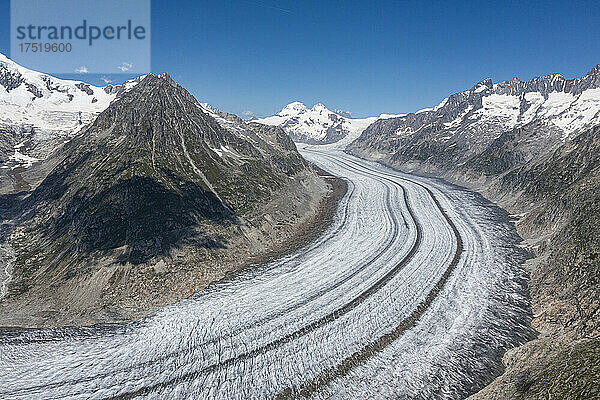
left=0, top=74, right=330, bottom=326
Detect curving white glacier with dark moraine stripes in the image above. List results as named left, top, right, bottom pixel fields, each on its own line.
left=0, top=146, right=530, bottom=399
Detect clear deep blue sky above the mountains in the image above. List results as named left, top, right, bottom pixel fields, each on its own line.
left=0, top=0, right=600, bottom=116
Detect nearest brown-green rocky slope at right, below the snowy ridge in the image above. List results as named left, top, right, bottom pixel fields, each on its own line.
left=470, top=125, right=600, bottom=399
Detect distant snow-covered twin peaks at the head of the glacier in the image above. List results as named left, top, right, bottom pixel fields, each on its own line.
left=255, top=101, right=400, bottom=144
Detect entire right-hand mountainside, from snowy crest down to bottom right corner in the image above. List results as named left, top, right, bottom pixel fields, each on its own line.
left=349, top=65, right=600, bottom=399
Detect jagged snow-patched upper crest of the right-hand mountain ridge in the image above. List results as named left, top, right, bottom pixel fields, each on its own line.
left=396, top=64, right=600, bottom=136
